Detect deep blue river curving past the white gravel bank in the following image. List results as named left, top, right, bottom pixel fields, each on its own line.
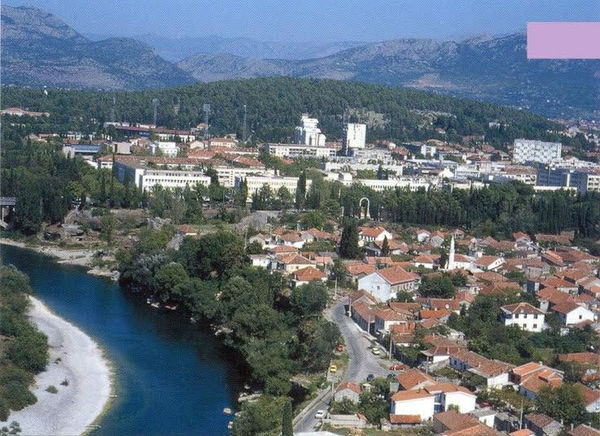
left=1, top=246, right=243, bottom=435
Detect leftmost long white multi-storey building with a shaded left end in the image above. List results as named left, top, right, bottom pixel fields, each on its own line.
left=114, top=161, right=210, bottom=191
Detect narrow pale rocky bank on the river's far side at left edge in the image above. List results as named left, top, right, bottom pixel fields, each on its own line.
left=0, top=238, right=119, bottom=281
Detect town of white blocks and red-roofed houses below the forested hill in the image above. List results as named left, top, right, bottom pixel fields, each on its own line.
left=2, top=97, right=600, bottom=436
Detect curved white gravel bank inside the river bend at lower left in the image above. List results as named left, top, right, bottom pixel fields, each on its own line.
left=9, top=297, right=112, bottom=435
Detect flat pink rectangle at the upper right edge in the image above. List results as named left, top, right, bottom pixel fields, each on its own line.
left=527, top=21, right=600, bottom=59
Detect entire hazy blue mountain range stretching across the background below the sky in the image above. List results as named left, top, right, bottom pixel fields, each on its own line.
left=2, top=6, right=600, bottom=119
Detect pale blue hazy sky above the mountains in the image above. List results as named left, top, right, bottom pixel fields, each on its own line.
left=4, top=0, right=600, bottom=41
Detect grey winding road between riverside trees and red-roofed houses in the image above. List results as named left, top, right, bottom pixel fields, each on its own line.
left=294, top=303, right=390, bottom=433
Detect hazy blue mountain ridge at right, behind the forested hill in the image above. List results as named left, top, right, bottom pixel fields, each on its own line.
left=177, top=34, right=600, bottom=119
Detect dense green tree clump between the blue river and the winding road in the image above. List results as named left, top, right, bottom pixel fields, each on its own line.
left=119, top=229, right=340, bottom=395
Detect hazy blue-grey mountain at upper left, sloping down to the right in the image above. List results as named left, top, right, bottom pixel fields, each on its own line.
left=1, top=5, right=194, bottom=90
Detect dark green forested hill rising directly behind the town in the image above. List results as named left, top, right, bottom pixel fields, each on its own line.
left=3, top=78, right=580, bottom=148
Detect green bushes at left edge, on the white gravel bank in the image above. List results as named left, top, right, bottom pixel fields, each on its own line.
left=0, top=266, right=48, bottom=421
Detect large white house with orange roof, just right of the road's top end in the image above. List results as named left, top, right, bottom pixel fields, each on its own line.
left=358, top=266, right=421, bottom=302
